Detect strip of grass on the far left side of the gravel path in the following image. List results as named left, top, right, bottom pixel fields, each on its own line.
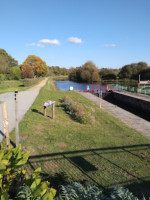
left=0, top=79, right=42, bottom=94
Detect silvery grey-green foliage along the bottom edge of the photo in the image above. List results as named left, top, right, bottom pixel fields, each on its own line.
left=55, top=182, right=150, bottom=200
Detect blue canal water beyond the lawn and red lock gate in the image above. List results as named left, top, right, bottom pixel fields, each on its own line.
left=56, top=81, right=110, bottom=91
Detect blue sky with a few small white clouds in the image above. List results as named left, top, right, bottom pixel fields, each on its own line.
left=0, top=0, right=150, bottom=68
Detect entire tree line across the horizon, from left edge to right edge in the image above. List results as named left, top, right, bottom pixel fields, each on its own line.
left=0, top=49, right=150, bottom=83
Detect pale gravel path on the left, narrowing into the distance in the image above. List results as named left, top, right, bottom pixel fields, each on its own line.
left=0, top=78, right=47, bottom=142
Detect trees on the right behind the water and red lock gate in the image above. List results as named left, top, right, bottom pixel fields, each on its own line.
left=69, top=62, right=150, bottom=83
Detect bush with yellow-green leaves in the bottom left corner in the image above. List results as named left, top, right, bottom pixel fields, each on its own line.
left=0, top=146, right=56, bottom=200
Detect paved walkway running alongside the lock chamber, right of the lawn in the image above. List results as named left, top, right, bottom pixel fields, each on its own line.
left=79, top=92, right=150, bottom=139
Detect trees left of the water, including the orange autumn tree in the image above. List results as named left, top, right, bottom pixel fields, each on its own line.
left=0, top=49, right=69, bottom=80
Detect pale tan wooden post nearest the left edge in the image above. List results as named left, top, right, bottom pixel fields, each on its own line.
left=3, top=103, right=10, bottom=148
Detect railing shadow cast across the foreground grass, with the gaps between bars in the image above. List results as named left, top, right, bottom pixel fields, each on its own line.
left=28, top=144, right=150, bottom=197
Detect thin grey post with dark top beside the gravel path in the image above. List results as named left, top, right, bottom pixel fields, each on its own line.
left=15, top=90, right=19, bottom=146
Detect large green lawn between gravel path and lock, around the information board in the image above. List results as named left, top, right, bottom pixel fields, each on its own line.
left=11, top=77, right=150, bottom=198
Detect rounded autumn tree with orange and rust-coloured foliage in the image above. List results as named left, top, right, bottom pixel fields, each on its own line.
left=22, top=55, right=48, bottom=78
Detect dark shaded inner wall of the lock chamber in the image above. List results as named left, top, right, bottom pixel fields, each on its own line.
left=108, top=92, right=150, bottom=114
